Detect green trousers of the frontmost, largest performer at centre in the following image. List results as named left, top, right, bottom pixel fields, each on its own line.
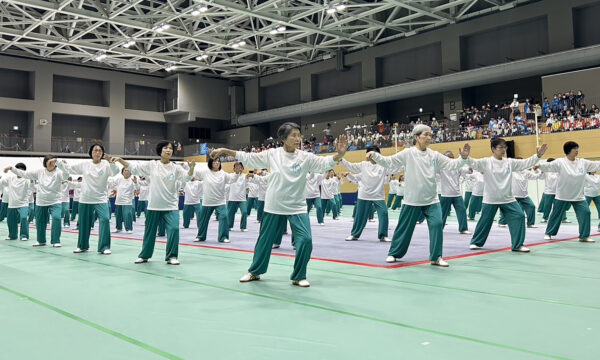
left=248, top=214, right=312, bottom=280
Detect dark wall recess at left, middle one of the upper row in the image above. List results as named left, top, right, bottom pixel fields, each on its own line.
left=52, top=75, right=109, bottom=106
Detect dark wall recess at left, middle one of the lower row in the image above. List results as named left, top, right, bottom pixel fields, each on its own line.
left=52, top=114, right=108, bottom=139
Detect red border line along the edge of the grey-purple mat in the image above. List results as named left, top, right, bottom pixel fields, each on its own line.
left=51, top=230, right=600, bottom=269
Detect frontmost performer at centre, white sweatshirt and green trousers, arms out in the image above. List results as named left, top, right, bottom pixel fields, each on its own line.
left=211, top=122, right=348, bottom=287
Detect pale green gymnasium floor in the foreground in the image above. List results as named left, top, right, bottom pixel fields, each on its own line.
left=0, top=207, right=600, bottom=360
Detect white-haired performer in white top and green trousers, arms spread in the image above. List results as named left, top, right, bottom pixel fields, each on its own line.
left=367, top=124, right=471, bottom=267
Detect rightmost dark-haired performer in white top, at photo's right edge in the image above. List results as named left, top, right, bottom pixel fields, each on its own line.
left=540, top=141, right=600, bottom=242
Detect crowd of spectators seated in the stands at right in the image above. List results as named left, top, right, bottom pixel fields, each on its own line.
left=232, top=91, right=600, bottom=153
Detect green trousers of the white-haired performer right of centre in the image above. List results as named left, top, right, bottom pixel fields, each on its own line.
left=388, top=203, right=444, bottom=261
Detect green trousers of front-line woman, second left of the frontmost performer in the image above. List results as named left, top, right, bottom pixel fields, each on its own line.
left=78, top=203, right=110, bottom=252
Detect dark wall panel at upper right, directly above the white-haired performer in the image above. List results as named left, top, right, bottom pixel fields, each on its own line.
left=379, top=43, right=442, bottom=86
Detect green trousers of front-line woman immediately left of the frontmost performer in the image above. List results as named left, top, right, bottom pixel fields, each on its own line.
left=138, top=210, right=179, bottom=261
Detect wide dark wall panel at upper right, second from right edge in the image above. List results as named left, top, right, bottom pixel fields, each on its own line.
left=460, top=17, right=548, bottom=70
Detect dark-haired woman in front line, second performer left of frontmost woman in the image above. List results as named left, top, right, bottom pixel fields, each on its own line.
left=56, top=144, right=119, bottom=255
